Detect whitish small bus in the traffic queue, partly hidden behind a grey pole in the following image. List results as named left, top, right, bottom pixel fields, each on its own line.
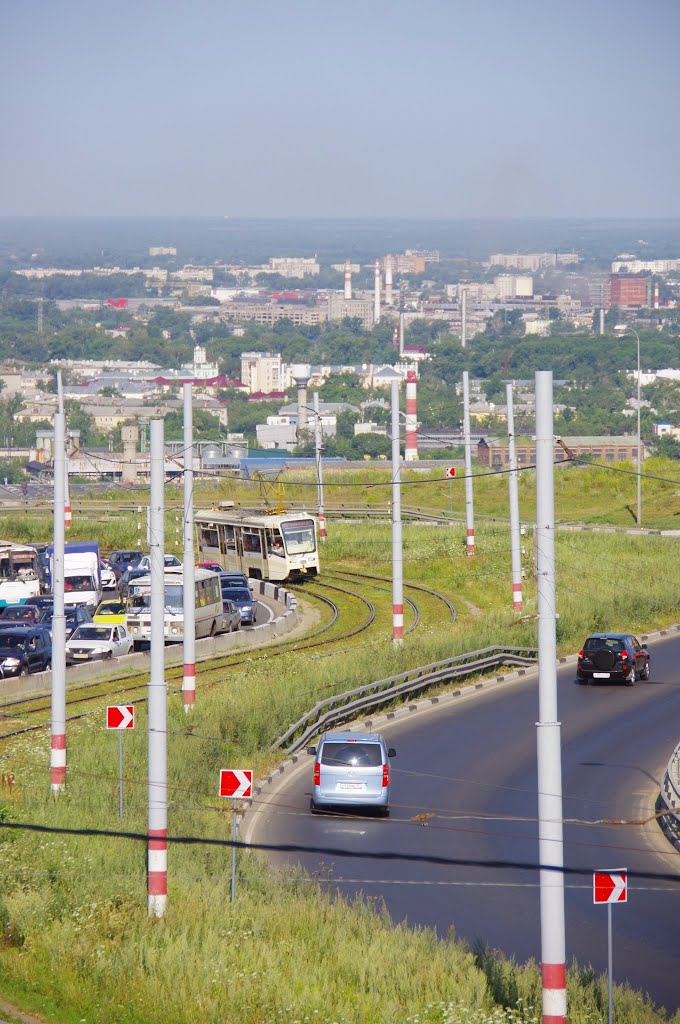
left=125, top=566, right=224, bottom=648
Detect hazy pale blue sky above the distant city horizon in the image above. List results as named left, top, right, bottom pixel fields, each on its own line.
left=0, top=0, right=680, bottom=219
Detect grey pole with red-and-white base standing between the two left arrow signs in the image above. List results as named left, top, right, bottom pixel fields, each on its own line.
left=147, top=419, right=168, bottom=918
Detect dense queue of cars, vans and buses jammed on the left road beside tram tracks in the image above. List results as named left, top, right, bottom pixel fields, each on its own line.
left=0, top=541, right=266, bottom=678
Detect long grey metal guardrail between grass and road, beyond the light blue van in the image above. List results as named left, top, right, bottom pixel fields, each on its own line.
left=269, top=647, right=539, bottom=754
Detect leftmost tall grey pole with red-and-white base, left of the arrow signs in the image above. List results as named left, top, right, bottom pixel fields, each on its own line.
left=49, top=380, right=67, bottom=794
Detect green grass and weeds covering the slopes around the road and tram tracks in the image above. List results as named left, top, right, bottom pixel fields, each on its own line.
left=0, top=466, right=680, bottom=1024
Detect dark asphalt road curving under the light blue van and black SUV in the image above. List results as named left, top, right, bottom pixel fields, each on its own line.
left=249, top=638, right=680, bottom=1010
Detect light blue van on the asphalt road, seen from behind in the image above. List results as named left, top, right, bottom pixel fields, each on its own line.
left=307, top=732, right=396, bottom=817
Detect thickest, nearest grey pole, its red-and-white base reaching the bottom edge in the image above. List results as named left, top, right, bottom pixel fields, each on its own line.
left=536, top=370, right=566, bottom=1024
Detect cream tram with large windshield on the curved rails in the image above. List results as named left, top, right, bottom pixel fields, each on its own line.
left=194, top=508, right=318, bottom=583
